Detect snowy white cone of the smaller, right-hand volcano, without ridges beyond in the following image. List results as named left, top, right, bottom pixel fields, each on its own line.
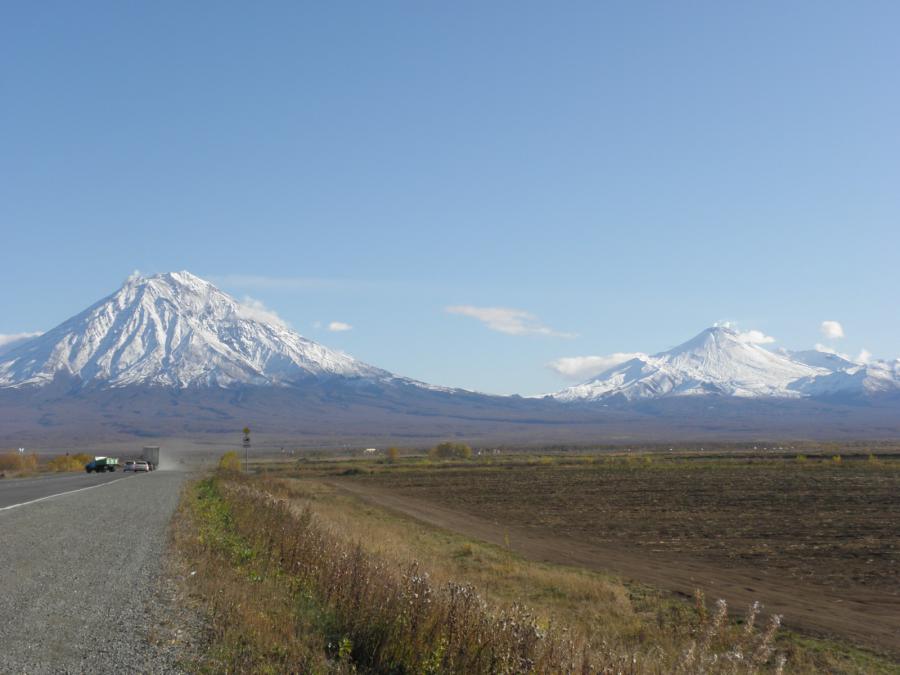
left=553, top=327, right=832, bottom=401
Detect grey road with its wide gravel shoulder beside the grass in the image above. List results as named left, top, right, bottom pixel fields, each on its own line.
left=0, top=471, right=184, bottom=673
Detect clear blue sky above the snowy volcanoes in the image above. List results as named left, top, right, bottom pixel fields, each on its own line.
left=0, top=2, right=900, bottom=393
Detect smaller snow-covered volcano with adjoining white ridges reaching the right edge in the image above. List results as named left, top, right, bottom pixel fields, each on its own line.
left=553, top=326, right=900, bottom=402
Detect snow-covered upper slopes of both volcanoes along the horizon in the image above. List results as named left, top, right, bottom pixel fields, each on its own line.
left=0, top=271, right=900, bottom=414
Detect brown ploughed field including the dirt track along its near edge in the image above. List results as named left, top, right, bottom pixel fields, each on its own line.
left=336, top=460, right=900, bottom=655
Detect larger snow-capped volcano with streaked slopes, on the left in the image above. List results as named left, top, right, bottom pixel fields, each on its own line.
left=0, top=272, right=394, bottom=388
